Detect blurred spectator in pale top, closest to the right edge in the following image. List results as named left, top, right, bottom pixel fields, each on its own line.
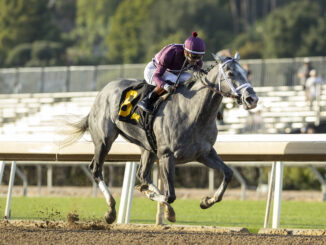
left=306, top=69, right=324, bottom=106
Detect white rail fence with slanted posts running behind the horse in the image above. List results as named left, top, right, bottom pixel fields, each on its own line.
left=0, top=134, right=326, bottom=228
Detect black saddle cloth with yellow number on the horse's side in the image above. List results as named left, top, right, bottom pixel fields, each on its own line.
left=118, top=81, right=165, bottom=153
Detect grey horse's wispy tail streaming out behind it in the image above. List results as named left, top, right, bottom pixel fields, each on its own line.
left=59, top=115, right=89, bottom=148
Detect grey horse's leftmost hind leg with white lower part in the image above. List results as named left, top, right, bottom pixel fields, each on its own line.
left=89, top=123, right=118, bottom=224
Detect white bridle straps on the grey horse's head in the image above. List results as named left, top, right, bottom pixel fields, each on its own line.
left=200, top=58, right=251, bottom=104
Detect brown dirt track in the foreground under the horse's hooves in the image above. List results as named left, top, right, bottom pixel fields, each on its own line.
left=0, top=221, right=326, bottom=245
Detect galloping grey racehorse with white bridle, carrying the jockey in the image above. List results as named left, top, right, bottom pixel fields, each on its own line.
left=62, top=53, right=258, bottom=224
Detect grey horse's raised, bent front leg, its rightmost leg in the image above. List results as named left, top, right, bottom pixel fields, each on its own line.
left=197, top=149, right=233, bottom=209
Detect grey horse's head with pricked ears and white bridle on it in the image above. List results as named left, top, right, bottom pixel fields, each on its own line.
left=208, top=53, right=259, bottom=110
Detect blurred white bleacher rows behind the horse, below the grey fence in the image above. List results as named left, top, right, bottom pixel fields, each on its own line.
left=0, top=85, right=326, bottom=139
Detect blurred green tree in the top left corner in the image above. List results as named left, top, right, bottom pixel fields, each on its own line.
left=0, top=0, right=60, bottom=61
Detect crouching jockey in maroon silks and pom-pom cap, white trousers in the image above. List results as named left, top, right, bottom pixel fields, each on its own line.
left=138, top=32, right=205, bottom=113
